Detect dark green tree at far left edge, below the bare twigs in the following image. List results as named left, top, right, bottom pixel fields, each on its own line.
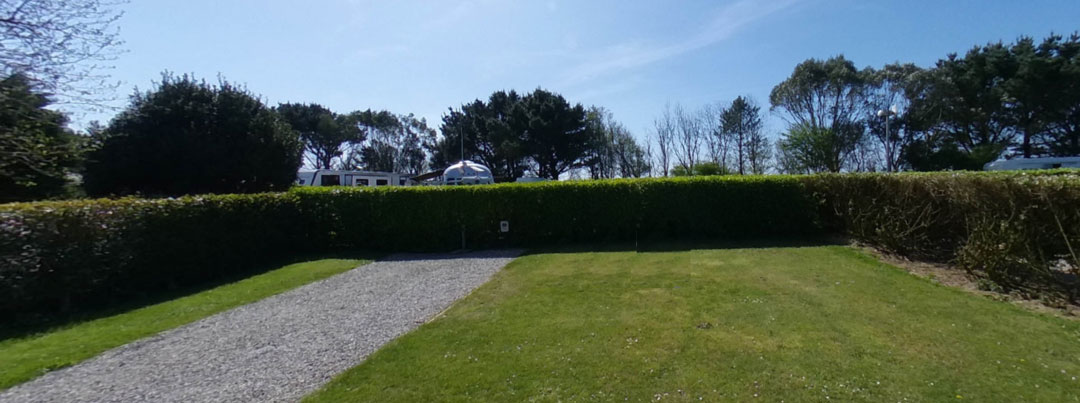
left=0, top=75, right=81, bottom=203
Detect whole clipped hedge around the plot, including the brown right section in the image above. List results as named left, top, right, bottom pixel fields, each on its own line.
left=0, top=171, right=1080, bottom=318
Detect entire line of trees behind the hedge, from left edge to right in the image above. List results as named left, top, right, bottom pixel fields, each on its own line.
left=0, top=0, right=1080, bottom=202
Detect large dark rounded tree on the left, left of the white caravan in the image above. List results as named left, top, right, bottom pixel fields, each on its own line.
left=84, top=73, right=302, bottom=196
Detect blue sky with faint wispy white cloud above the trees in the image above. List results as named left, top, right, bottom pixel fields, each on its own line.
left=86, top=0, right=1080, bottom=141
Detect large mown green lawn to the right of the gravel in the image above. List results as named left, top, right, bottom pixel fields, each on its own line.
left=309, top=246, right=1080, bottom=402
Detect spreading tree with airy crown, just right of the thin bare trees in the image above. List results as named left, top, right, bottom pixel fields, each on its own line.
left=769, top=56, right=870, bottom=172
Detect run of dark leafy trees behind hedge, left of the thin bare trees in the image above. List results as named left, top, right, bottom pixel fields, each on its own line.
left=0, top=73, right=649, bottom=201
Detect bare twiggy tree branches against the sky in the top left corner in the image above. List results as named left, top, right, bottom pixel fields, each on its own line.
left=0, top=0, right=123, bottom=107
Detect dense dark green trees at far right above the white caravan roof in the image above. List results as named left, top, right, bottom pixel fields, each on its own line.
left=905, top=33, right=1080, bottom=166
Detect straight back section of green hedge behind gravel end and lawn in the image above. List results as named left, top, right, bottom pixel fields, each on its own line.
left=292, top=176, right=816, bottom=251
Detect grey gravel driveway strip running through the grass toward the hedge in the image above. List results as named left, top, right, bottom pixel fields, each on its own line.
left=0, top=251, right=521, bottom=402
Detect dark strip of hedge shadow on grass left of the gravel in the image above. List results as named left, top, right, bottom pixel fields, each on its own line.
left=0, top=251, right=384, bottom=341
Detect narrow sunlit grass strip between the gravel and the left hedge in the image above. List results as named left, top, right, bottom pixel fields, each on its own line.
left=0, top=259, right=368, bottom=389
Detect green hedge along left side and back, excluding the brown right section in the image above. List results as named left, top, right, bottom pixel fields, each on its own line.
left=0, top=176, right=820, bottom=314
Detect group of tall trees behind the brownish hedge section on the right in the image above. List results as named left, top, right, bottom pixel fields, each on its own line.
left=769, top=33, right=1080, bottom=173
